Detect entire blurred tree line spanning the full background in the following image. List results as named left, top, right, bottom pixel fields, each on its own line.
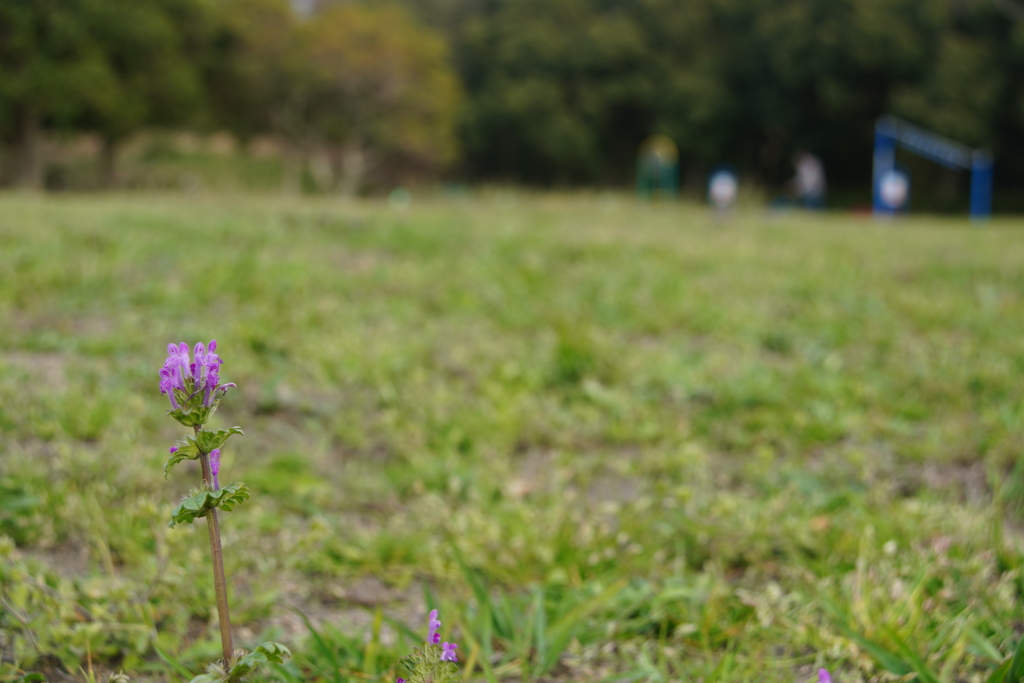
left=0, top=0, right=1024, bottom=193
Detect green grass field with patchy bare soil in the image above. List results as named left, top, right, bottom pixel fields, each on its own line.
left=0, top=193, right=1024, bottom=683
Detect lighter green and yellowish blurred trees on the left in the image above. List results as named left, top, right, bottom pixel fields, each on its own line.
left=0, top=0, right=461, bottom=194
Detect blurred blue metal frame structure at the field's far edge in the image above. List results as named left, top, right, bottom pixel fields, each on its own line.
left=871, top=116, right=992, bottom=220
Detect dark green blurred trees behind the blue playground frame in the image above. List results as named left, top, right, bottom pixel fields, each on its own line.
left=408, top=0, right=1024, bottom=192
